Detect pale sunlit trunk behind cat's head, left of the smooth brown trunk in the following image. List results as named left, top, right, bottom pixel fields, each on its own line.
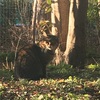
left=51, top=0, right=60, bottom=64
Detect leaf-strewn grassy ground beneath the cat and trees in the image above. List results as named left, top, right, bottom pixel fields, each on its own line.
left=0, top=63, right=100, bottom=100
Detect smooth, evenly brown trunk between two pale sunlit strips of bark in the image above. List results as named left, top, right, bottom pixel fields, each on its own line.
left=59, top=0, right=69, bottom=52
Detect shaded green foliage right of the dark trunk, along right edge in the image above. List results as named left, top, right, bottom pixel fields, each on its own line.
left=86, top=0, right=100, bottom=64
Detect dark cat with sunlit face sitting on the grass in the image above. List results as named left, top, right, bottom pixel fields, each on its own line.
left=15, top=35, right=58, bottom=80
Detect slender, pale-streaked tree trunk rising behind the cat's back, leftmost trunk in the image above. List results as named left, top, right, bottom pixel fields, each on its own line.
left=31, top=0, right=44, bottom=43
